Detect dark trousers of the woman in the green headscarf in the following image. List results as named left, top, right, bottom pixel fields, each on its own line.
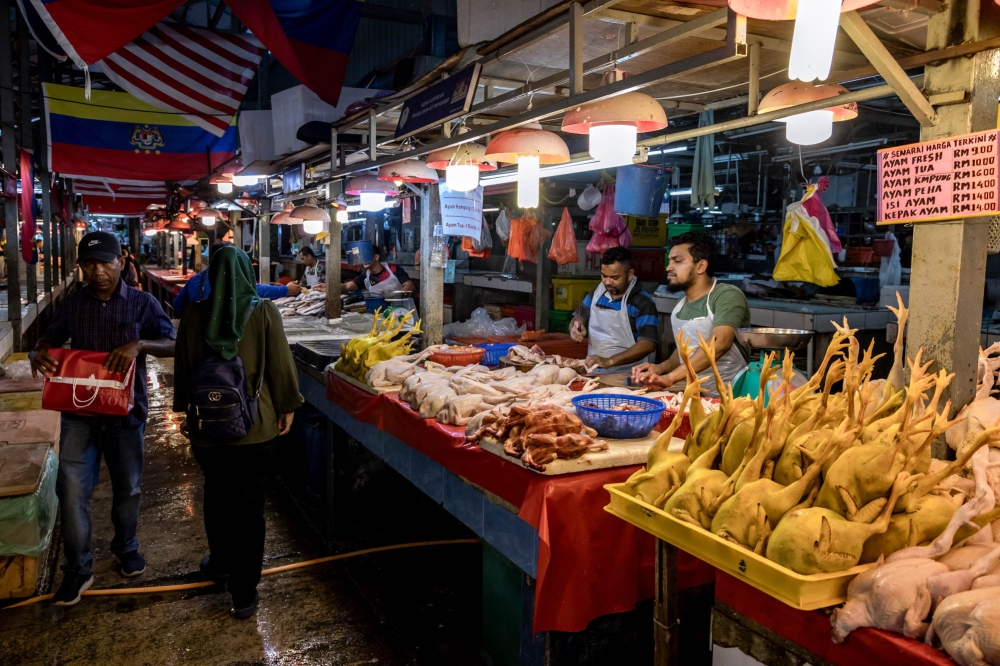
left=192, top=443, right=272, bottom=608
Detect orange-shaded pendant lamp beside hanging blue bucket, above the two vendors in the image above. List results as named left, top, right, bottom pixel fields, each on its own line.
left=562, top=69, right=667, bottom=166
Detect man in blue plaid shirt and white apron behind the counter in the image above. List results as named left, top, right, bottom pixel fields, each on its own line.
left=569, top=247, right=660, bottom=373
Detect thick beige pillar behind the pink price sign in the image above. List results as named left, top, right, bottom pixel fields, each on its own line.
left=906, top=1, right=1000, bottom=457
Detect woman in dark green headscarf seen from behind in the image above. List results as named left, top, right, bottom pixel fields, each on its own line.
left=173, top=247, right=303, bottom=619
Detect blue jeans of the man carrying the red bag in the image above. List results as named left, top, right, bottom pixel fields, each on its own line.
left=56, top=414, right=146, bottom=576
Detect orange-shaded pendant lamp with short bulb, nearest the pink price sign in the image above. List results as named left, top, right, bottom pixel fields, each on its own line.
left=760, top=81, right=858, bottom=146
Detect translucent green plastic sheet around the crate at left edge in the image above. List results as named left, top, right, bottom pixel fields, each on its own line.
left=0, top=452, right=59, bottom=557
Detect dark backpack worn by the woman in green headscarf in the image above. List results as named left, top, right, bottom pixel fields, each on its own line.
left=187, top=303, right=265, bottom=440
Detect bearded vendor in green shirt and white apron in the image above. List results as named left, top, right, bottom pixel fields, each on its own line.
left=632, top=232, right=750, bottom=397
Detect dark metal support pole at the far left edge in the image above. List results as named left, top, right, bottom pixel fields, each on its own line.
left=0, top=0, right=23, bottom=352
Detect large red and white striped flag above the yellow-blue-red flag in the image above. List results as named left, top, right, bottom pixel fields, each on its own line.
left=100, top=23, right=264, bottom=136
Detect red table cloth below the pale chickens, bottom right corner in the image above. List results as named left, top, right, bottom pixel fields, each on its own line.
left=715, top=571, right=955, bottom=666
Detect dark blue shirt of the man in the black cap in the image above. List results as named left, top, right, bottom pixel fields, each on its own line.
left=41, top=281, right=177, bottom=428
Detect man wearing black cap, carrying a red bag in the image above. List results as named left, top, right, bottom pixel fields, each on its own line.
left=31, top=231, right=177, bottom=606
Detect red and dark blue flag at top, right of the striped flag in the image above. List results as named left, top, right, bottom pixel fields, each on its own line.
left=227, top=0, right=361, bottom=106
